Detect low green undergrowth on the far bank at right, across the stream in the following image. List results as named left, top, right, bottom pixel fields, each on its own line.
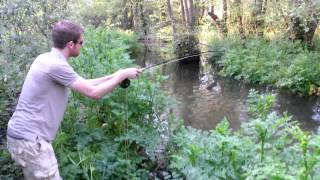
left=210, top=36, right=320, bottom=96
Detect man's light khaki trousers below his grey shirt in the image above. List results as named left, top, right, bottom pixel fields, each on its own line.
left=7, top=136, right=61, bottom=180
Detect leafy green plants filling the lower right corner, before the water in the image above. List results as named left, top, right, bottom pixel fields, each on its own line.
left=170, top=90, right=320, bottom=179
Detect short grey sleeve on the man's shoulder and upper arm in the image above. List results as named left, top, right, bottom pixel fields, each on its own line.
left=48, top=64, right=79, bottom=87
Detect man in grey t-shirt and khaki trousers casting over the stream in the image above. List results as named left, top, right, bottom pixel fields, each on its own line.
left=7, top=21, right=142, bottom=179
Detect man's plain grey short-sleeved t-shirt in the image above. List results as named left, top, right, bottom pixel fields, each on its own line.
left=7, top=48, right=81, bottom=141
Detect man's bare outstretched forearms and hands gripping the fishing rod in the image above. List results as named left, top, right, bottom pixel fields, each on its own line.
left=69, top=68, right=142, bottom=100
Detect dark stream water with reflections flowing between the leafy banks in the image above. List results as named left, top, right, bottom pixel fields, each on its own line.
left=138, top=42, right=320, bottom=132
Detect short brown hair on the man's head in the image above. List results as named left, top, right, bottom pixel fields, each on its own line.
left=52, top=20, right=84, bottom=49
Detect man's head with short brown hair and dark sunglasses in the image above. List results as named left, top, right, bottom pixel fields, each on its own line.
left=52, top=20, right=84, bottom=57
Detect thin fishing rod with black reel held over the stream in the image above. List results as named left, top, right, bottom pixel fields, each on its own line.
left=120, top=50, right=225, bottom=88
